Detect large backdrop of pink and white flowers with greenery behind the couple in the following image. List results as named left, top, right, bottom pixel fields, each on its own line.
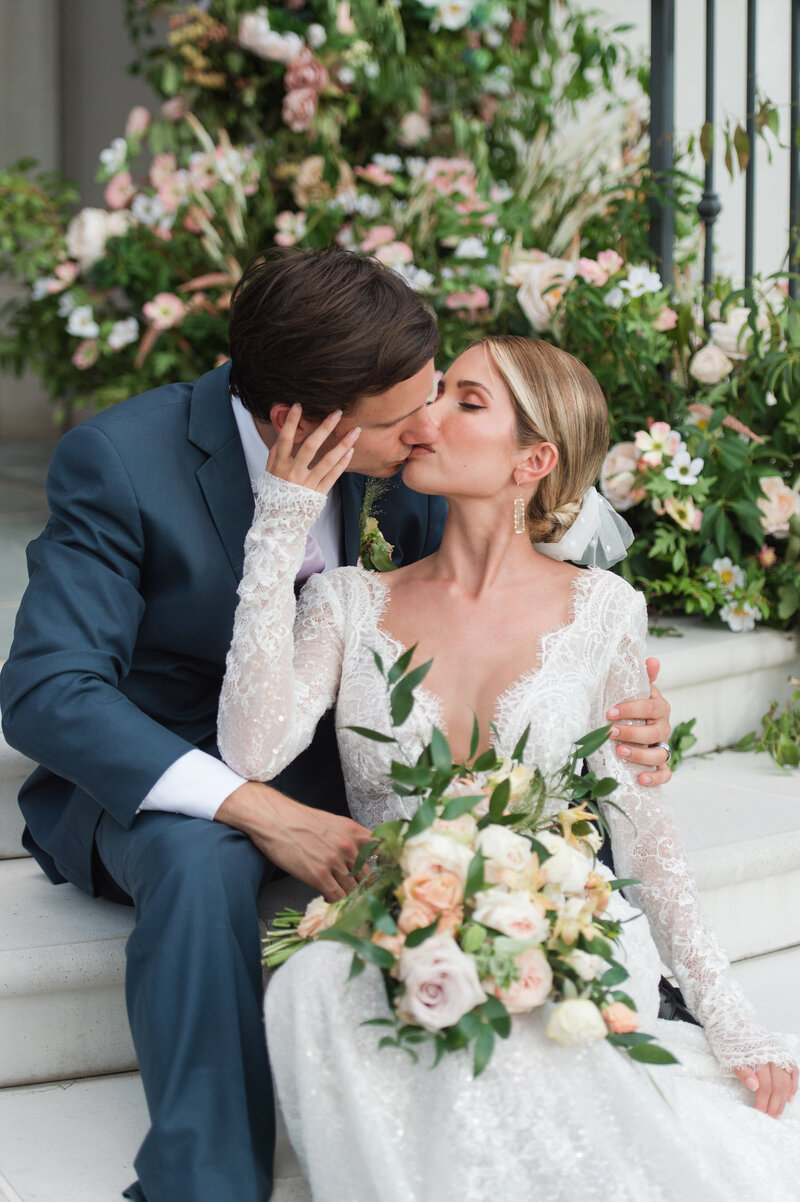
left=0, top=0, right=800, bottom=630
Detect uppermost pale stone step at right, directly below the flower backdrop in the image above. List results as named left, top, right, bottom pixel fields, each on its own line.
left=647, top=618, right=800, bottom=755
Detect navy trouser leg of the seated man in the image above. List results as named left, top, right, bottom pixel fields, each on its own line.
left=96, top=813, right=275, bottom=1202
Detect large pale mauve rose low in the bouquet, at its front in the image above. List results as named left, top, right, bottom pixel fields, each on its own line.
left=396, top=932, right=485, bottom=1031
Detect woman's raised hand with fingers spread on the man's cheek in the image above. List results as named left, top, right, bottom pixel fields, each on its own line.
left=267, top=405, right=360, bottom=493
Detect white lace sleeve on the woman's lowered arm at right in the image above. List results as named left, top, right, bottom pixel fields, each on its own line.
left=590, top=579, right=793, bottom=1069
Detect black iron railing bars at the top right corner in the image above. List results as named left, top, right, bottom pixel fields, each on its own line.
left=650, top=0, right=800, bottom=298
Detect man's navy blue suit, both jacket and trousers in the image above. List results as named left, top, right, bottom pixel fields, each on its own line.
left=0, top=367, right=443, bottom=1202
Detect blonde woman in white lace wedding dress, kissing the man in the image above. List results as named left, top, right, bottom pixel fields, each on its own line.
left=219, top=338, right=800, bottom=1202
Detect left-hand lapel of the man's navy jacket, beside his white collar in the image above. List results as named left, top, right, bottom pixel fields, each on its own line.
left=189, top=363, right=253, bottom=581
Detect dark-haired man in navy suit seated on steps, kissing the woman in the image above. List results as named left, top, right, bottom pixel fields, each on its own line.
left=0, top=251, right=668, bottom=1202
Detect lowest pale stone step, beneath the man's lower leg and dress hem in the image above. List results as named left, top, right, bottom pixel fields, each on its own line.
left=0, top=948, right=800, bottom=1202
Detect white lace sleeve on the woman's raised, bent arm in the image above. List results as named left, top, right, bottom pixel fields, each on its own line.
left=217, top=474, right=342, bottom=780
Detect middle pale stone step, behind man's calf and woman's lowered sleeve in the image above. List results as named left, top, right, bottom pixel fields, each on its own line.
left=0, top=751, right=800, bottom=1085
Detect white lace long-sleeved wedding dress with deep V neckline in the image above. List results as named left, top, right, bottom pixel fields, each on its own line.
left=220, top=476, right=800, bottom=1202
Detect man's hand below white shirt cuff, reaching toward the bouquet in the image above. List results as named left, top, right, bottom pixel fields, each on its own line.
left=215, top=780, right=372, bottom=902
